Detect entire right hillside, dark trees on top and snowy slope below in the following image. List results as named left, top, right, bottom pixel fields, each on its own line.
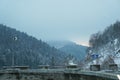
left=86, top=21, right=120, bottom=69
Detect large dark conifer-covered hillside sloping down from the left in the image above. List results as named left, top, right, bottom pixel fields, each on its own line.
left=0, top=24, right=65, bottom=68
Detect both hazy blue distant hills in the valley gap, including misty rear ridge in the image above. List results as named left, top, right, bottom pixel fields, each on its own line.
left=48, top=41, right=87, bottom=61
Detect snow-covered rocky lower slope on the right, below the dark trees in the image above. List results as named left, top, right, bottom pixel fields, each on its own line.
left=86, top=39, right=120, bottom=68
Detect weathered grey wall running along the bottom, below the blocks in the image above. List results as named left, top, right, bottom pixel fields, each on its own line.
left=0, top=68, right=120, bottom=80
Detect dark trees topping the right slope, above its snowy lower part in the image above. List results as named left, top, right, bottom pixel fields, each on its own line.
left=89, top=21, right=120, bottom=49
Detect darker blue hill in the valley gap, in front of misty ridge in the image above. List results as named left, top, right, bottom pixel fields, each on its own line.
left=59, top=43, right=87, bottom=61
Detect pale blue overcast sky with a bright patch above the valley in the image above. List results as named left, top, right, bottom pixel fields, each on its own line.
left=0, top=0, right=120, bottom=44
